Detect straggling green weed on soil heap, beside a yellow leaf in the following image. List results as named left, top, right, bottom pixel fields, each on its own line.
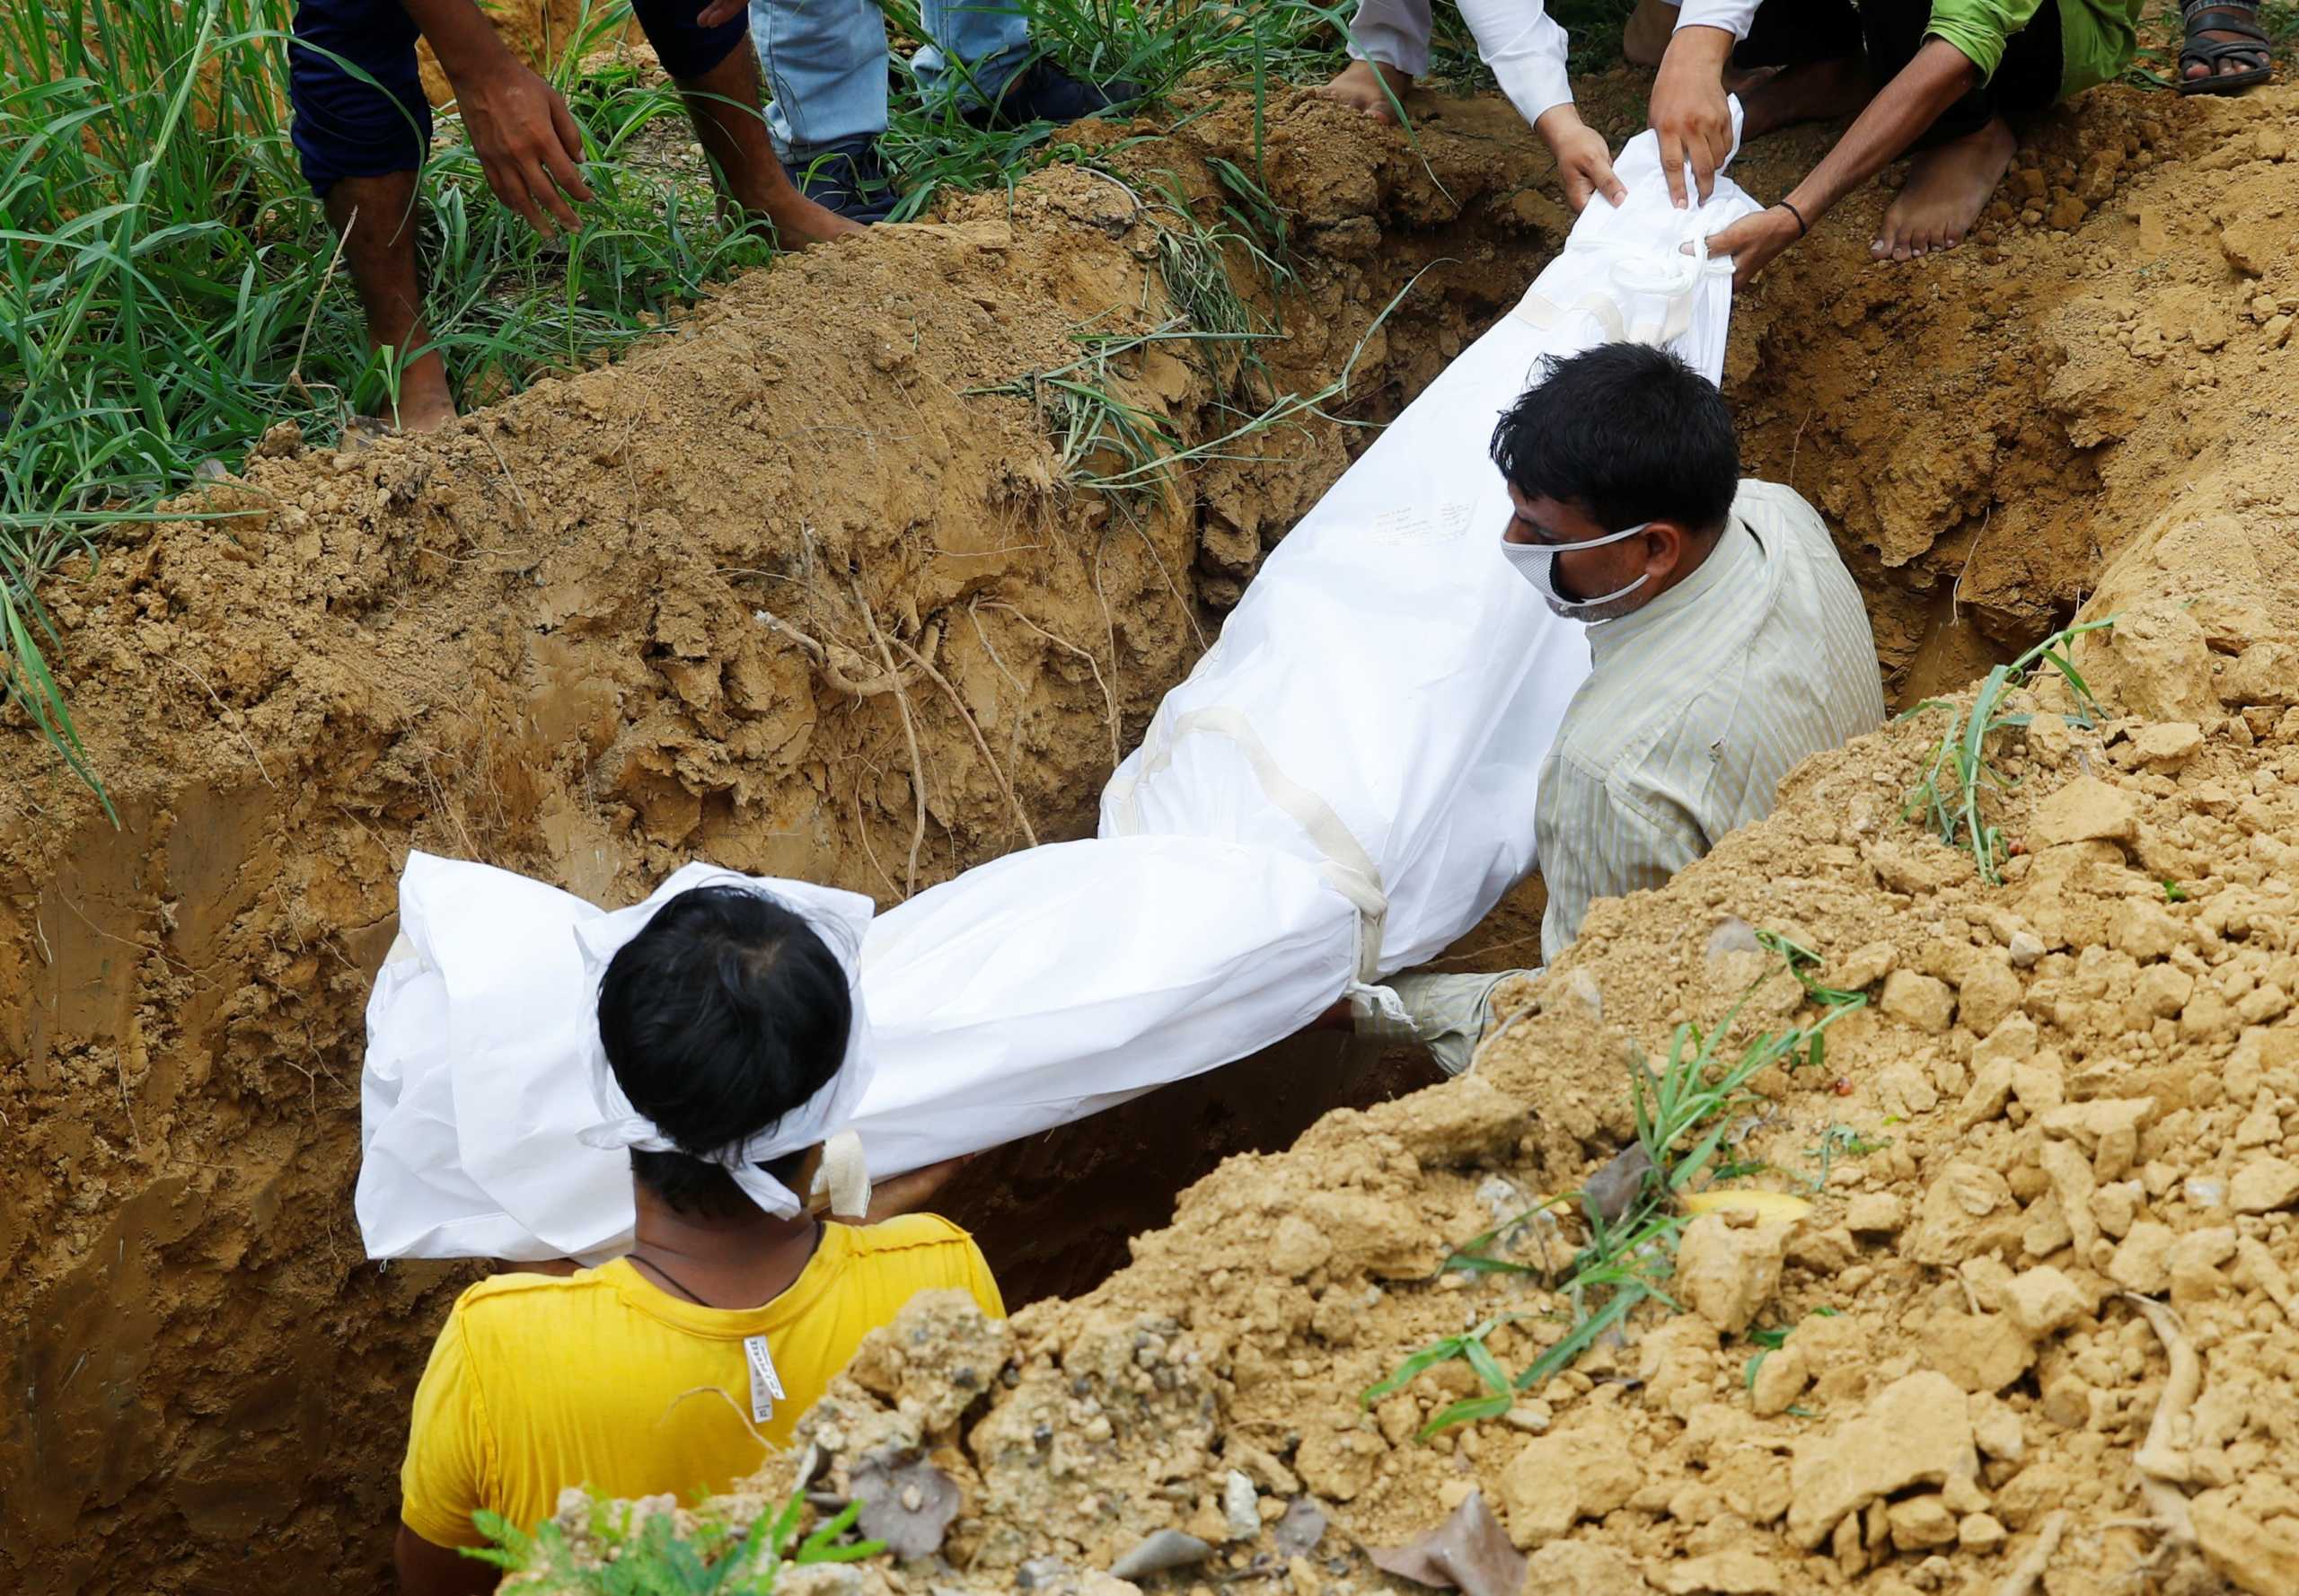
left=1363, top=931, right=1867, bottom=1440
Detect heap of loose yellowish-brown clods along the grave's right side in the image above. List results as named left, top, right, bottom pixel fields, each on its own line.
left=625, top=94, right=2299, bottom=1596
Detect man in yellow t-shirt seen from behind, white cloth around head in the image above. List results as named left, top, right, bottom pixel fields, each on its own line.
left=398, top=886, right=1005, bottom=1596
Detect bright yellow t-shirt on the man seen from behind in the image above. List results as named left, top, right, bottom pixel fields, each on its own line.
left=400, top=1214, right=1005, bottom=1546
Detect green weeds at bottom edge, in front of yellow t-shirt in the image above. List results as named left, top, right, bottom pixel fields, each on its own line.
left=464, top=1495, right=885, bottom=1596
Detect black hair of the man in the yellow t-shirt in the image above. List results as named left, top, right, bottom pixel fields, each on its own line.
left=598, top=886, right=853, bottom=1214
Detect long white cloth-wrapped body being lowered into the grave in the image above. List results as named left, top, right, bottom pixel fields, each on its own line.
left=357, top=134, right=1757, bottom=1260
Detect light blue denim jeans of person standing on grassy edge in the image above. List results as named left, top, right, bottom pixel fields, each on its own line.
left=750, top=0, right=1030, bottom=163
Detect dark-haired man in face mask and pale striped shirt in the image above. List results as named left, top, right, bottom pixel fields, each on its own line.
left=1356, top=343, right=1883, bottom=1074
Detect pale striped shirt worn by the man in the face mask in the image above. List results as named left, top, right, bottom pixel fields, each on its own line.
left=1534, top=481, right=1883, bottom=961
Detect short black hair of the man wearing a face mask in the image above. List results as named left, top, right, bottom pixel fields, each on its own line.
left=1492, top=343, right=1740, bottom=533
